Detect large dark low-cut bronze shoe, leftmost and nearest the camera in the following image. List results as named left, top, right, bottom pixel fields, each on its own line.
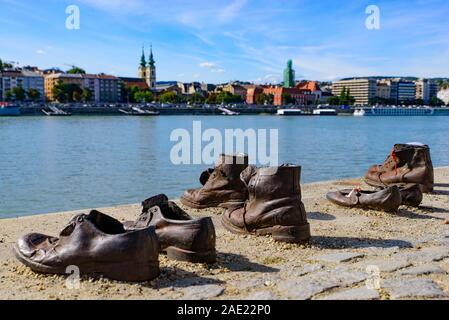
left=13, top=210, right=159, bottom=281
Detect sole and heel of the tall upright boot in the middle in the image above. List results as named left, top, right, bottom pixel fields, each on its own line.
left=221, top=217, right=311, bottom=244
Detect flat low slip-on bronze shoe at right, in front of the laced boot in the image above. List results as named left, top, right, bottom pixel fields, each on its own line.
left=326, top=186, right=402, bottom=212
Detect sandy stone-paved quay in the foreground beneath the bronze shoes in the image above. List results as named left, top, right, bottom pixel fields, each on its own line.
left=0, top=167, right=449, bottom=299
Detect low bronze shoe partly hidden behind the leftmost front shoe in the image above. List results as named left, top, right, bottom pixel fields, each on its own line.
left=125, top=194, right=216, bottom=263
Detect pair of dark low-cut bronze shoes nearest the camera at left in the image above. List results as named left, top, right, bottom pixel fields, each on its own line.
left=14, top=195, right=216, bottom=281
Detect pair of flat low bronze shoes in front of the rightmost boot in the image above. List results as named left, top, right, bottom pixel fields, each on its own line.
left=326, top=184, right=423, bottom=212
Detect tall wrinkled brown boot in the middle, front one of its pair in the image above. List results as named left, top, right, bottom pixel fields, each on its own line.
left=222, top=165, right=310, bottom=243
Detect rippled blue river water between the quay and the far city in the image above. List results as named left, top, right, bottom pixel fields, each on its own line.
left=0, top=116, right=449, bottom=218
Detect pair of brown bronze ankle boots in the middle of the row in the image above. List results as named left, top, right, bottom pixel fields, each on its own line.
left=181, top=155, right=310, bottom=243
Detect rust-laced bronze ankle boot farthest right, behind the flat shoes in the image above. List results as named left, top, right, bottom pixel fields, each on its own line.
left=365, top=144, right=434, bottom=193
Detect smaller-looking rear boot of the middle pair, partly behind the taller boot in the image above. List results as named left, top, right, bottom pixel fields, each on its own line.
left=181, top=155, right=248, bottom=209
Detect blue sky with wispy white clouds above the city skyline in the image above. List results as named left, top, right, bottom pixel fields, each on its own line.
left=0, top=0, right=449, bottom=83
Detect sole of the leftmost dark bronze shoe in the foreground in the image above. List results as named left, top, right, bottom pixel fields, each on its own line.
left=13, top=245, right=160, bottom=282
